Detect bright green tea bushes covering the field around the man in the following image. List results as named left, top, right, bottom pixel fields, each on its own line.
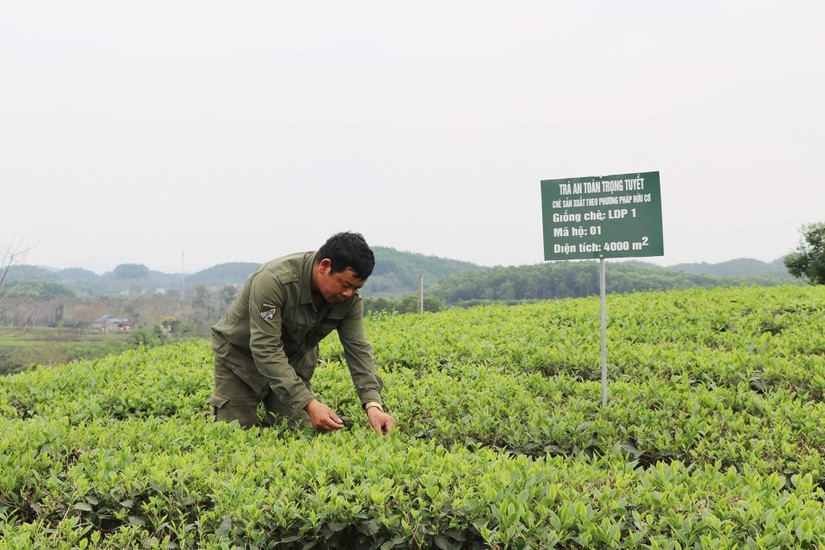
left=0, top=287, right=825, bottom=549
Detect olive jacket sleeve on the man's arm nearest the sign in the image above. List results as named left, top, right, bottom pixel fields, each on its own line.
left=338, top=299, right=384, bottom=405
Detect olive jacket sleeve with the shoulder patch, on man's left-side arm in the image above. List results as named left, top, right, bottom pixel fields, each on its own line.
left=249, top=272, right=315, bottom=411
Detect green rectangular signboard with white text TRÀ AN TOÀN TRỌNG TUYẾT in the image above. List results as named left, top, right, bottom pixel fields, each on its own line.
left=541, top=172, right=665, bottom=260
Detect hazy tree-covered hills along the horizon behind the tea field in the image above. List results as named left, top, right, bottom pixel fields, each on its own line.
left=6, top=246, right=801, bottom=305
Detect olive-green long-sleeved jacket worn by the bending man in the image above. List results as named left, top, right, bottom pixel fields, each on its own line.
left=212, top=252, right=383, bottom=409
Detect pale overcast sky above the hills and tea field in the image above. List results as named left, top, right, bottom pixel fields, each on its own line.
left=0, top=0, right=825, bottom=273
